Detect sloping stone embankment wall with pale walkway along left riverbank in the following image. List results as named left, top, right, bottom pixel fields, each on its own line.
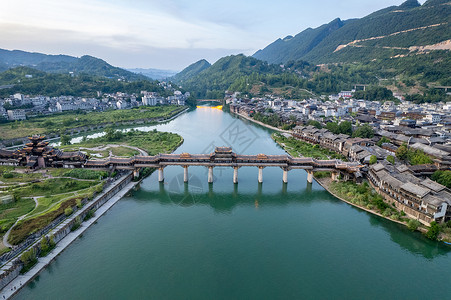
left=0, top=172, right=139, bottom=299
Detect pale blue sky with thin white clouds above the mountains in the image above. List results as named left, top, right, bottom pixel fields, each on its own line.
left=0, top=0, right=425, bottom=71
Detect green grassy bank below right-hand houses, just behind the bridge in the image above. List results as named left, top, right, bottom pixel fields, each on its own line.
left=272, top=133, right=346, bottom=161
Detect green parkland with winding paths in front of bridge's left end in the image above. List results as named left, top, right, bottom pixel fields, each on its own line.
left=0, top=166, right=109, bottom=245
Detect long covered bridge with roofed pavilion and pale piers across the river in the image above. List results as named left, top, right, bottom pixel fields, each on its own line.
left=83, top=147, right=363, bottom=183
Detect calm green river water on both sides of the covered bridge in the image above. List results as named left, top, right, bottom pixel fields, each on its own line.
left=16, top=108, right=451, bottom=299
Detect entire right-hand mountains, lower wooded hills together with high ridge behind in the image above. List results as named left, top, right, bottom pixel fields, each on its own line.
left=172, top=0, right=451, bottom=101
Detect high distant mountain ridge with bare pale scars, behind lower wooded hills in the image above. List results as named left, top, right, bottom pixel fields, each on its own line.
left=253, top=0, right=451, bottom=64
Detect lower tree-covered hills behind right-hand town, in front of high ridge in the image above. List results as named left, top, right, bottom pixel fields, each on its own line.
left=173, top=51, right=451, bottom=103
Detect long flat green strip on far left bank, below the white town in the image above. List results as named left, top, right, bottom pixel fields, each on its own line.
left=0, top=105, right=186, bottom=140
